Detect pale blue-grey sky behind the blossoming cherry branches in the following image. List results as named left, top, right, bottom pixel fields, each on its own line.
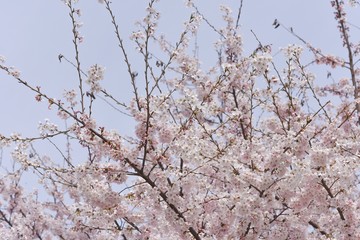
left=0, top=0, right=360, bottom=178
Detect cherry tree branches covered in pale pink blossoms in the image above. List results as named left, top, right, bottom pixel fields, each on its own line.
left=0, top=0, right=360, bottom=240
